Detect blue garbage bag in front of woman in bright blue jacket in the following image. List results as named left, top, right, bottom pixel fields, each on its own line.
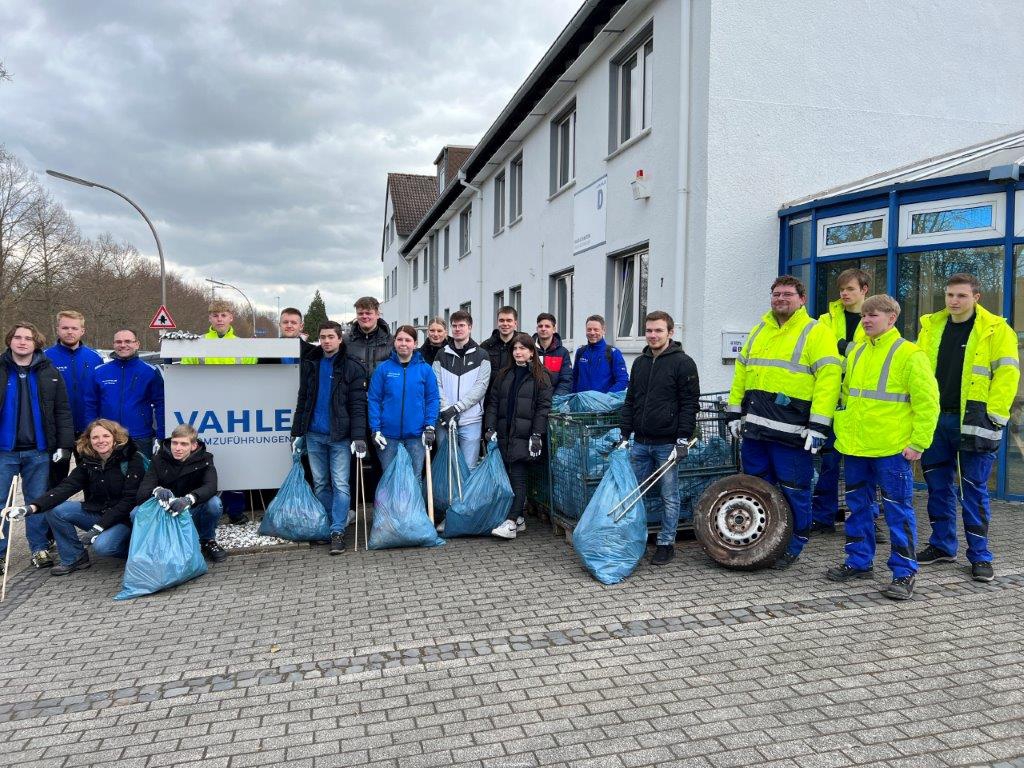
left=368, top=443, right=444, bottom=549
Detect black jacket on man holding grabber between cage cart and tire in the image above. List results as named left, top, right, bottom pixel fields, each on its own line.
left=620, top=341, right=700, bottom=445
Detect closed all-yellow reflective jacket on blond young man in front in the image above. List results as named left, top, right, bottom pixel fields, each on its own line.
left=833, top=328, right=939, bottom=458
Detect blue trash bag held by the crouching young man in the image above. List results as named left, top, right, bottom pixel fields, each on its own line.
left=114, top=499, right=206, bottom=600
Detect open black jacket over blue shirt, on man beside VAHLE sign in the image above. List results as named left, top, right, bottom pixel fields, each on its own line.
left=292, top=344, right=369, bottom=442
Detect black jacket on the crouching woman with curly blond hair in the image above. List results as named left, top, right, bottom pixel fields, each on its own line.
left=31, top=440, right=145, bottom=530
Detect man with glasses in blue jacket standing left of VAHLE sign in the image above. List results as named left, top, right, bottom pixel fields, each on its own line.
left=85, top=328, right=164, bottom=457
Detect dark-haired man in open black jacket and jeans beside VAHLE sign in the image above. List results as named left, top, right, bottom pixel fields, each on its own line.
left=292, top=321, right=367, bottom=555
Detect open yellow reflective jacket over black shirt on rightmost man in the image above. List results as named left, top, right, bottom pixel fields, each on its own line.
left=918, top=304, right=1021, bottom=453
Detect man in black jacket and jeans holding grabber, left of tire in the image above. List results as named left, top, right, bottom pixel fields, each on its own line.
left=618, top=310, right=700, bottom=565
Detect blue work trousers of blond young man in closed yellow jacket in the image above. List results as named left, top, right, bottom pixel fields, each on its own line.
left=846, top=454, right=918, bottom=579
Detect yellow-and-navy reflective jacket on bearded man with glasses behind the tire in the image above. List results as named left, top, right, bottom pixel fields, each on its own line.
left=728, top=307, right=842, bottom=446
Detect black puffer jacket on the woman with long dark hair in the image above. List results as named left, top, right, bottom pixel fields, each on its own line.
left=483, top=369, right=553, bottom=464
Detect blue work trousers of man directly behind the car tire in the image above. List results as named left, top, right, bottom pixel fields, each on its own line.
left=740, top=437, right=814, bottom=555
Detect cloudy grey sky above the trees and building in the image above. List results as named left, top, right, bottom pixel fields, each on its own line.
left=0, top=0, right=580, bottom=317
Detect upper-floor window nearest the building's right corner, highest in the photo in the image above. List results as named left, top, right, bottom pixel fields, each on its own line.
left=608, top=26, right=654, bottom=152
